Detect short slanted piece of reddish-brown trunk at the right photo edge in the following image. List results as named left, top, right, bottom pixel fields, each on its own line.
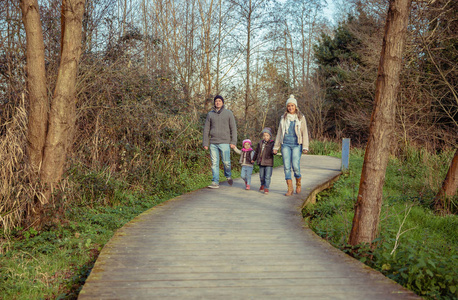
left=434, top=149, right=458, bottom=212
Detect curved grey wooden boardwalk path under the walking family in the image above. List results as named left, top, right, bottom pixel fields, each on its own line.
left=78, top=156, right=420, bottom=299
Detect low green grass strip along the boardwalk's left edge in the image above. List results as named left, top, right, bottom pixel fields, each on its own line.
left=0, top=190, right=174, bottom=299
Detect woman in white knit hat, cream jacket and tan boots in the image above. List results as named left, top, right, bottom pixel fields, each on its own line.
left=274, top=95, right=309, bottom=196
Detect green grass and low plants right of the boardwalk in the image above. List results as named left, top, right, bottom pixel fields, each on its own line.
left=303, top=144, right=458, bottom=299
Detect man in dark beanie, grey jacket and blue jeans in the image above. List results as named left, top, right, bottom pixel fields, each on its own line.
left=203, top=95, right=237, bottom=189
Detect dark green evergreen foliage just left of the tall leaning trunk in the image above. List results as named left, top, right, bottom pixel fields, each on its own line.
left=314, top=16, right=376, bottom=142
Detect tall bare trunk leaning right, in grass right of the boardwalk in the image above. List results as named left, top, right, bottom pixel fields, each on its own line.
left=350, top=0, right=411, bottom=245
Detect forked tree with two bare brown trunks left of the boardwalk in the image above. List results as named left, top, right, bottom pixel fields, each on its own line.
left=21, top=0, right=84, bottom=202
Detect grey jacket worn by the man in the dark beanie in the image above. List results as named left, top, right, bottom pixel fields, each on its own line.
left=202, top=106, right=237, bottom=147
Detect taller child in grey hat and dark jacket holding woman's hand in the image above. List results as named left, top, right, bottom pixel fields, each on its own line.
left=253, top=127, right=274, bottom=194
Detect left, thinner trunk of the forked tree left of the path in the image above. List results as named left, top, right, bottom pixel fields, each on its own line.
left=20, top=0, right=49, bottom=170
